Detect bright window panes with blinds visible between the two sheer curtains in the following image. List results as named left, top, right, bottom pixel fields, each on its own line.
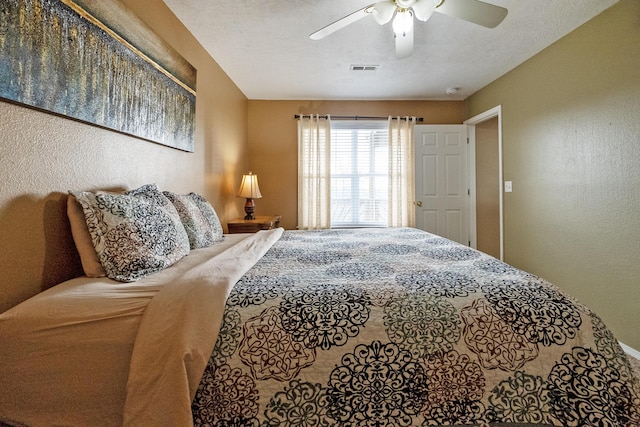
left=331, top=120, right=389, bottom=227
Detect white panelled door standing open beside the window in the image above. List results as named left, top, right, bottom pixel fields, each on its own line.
left=414, top=125, right=469, bottom=245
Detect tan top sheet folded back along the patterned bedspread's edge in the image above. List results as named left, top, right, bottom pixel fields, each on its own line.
left=124, top=228, right=283, bottom=427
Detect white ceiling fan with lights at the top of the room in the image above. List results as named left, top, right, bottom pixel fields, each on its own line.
left=309, top=0, right=507, bottom=58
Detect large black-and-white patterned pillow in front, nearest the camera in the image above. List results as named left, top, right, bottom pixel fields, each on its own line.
left=71, top=184, right=189, bottom=282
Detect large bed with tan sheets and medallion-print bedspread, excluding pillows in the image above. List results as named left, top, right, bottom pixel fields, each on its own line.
left=0, top=187, right=640, bottom=426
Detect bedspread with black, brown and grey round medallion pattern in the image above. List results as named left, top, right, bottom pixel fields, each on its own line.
left=192, top=228, right=640, bottom=427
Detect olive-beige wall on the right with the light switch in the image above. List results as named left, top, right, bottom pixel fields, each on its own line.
left=467, top=0, right=640, bottom=349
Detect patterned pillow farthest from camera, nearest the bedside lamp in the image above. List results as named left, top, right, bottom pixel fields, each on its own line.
left=163, top=191, right=223, bottom=249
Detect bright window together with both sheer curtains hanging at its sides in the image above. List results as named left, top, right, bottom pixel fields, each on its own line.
left=298, top=115, right=415, bottom=230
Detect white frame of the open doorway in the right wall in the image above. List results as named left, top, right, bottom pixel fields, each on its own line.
left=463, top=105, right=504, bottom=261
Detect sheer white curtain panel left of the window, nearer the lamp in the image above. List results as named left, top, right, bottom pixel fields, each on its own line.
left=298, top=115, right=331, bottom=230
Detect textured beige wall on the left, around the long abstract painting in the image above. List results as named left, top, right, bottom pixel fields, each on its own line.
left=0, top=0, right=248, bottom=311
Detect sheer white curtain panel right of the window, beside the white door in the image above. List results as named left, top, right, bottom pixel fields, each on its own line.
left=388, top=116, right=416, bottom=227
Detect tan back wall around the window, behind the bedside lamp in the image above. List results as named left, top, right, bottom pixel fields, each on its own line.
left=248, top=100, right=465, bottom=229
